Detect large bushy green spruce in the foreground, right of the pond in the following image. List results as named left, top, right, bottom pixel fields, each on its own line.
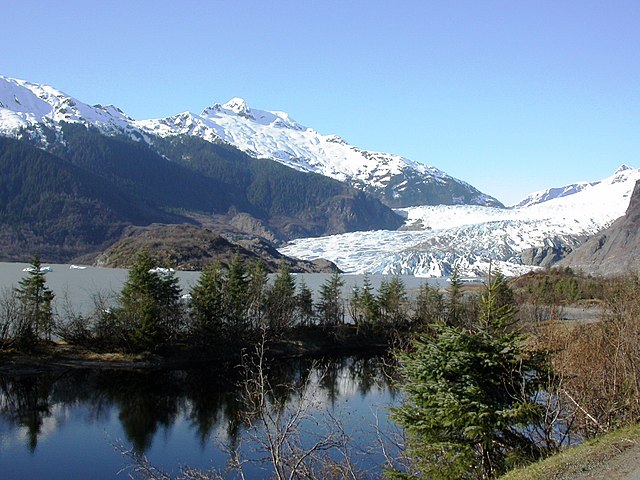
left=392, top=277, right=545, bottom=479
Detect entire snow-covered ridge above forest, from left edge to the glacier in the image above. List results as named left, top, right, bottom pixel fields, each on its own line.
left=0, top=76, right=502, bottom=207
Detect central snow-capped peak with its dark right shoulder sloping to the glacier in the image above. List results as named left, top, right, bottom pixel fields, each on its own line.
left=136, top=98, right=501, bottom=207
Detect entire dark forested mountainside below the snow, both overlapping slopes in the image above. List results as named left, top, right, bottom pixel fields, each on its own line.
left=0, top=124, right=401, bottom=261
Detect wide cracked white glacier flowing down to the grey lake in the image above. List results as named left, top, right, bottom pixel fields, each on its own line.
left=281, top=165, right=640, bottom=277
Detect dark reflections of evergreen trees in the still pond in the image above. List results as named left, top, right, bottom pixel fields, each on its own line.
left=0, top=356, right=396, bottom=454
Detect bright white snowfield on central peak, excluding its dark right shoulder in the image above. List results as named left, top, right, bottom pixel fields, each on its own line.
left=136, top=98, right=451, bottom=187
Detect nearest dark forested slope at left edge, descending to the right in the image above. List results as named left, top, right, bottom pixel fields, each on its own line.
left=0, top=138, right=184, bottom=261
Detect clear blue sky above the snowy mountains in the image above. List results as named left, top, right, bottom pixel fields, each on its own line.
left=0, top=0, right=640, bottom=204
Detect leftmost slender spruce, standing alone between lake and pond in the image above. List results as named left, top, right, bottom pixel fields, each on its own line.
left=16, top=255, right=55, bottom=348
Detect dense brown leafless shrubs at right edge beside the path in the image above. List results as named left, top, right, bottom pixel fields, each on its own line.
left=544, top=276, right=640, bottom=436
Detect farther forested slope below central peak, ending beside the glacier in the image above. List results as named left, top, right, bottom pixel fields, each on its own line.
left=154, top=136, right=402, bottom=238
